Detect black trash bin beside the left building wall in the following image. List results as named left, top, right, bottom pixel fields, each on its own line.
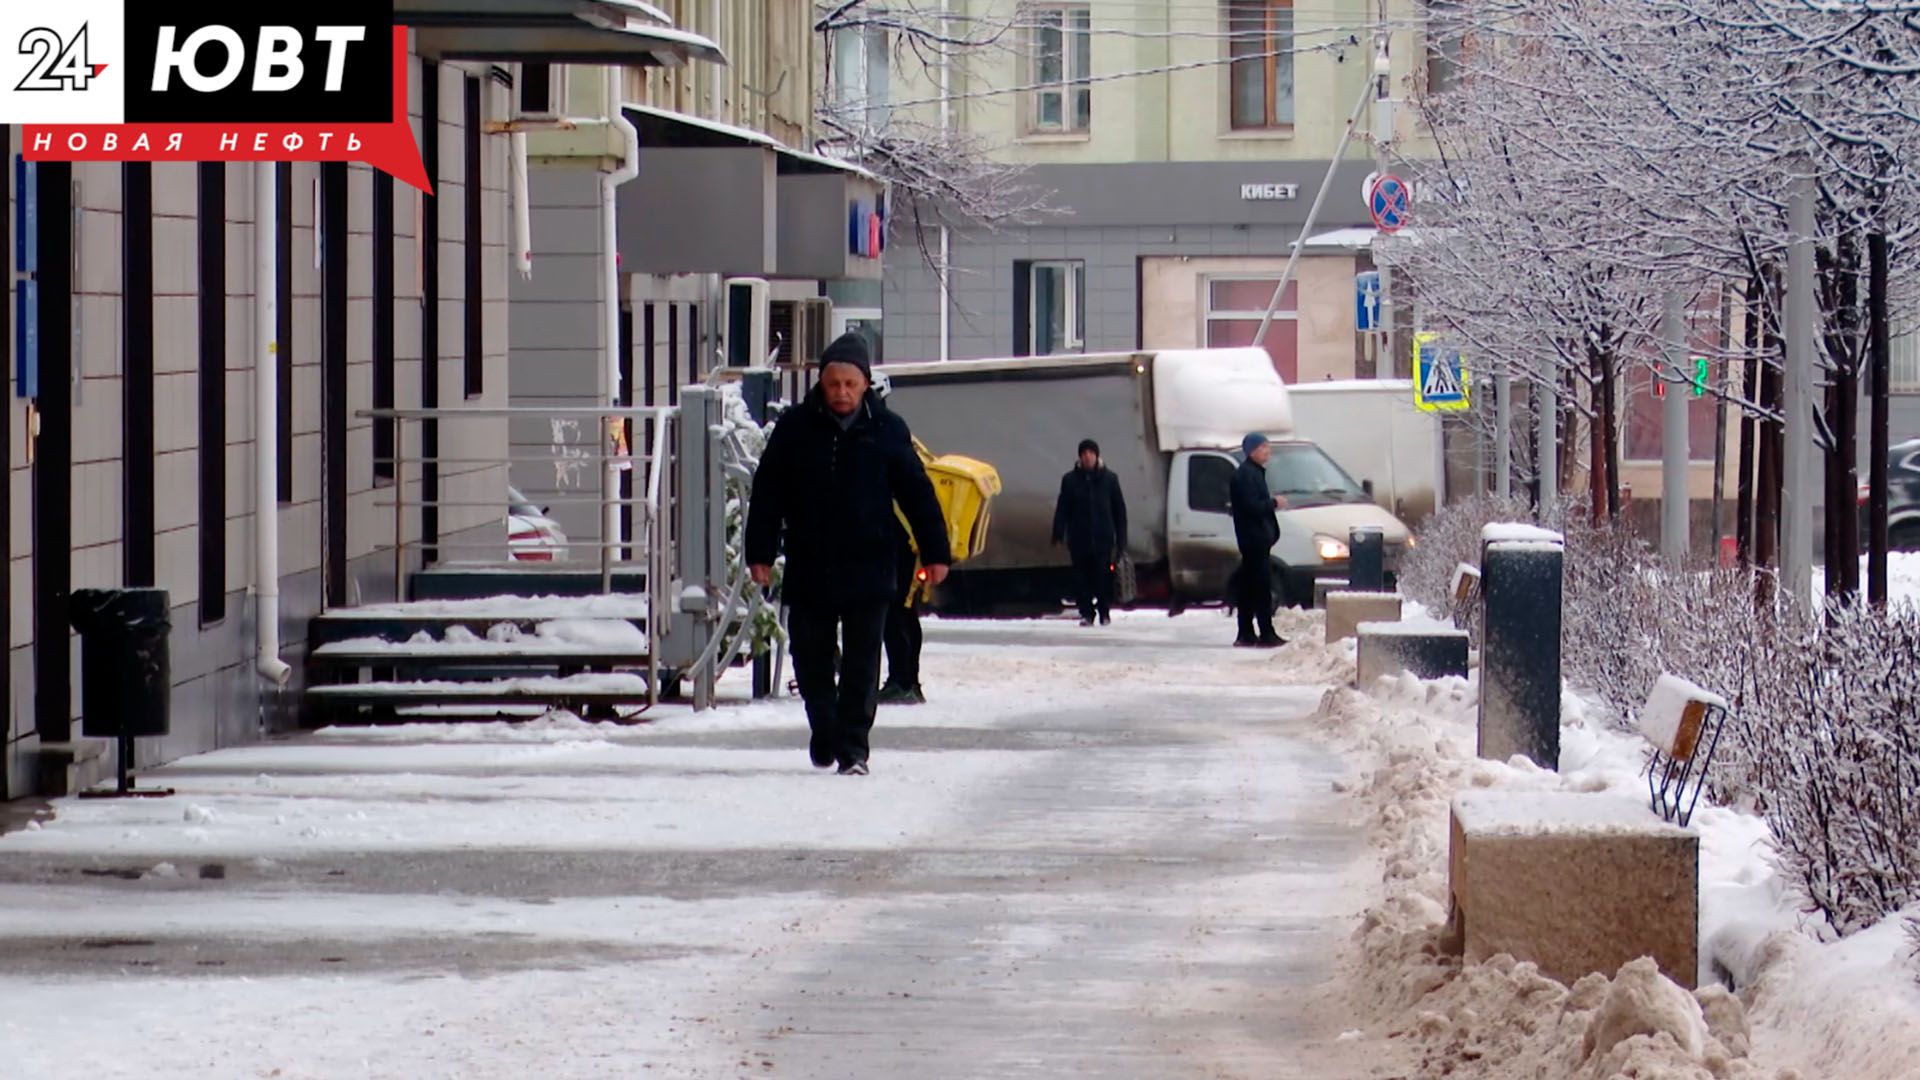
left=67, top=588, right=173, bottom=740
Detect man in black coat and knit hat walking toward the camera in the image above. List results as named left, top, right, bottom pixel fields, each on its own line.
left=747, top=334, right=952, bottom=776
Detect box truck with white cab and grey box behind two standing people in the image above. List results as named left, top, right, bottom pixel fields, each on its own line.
left=876, top=348, right=1407, bottom=613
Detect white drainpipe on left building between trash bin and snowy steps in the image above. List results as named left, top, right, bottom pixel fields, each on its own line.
left=253, top=161, right=294, bottom=686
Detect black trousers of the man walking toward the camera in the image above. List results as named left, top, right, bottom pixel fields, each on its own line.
left=787, top=601, right=887, bottom=765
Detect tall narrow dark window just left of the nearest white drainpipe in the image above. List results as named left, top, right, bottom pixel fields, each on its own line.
left=200, top=161, right=227, bottom=626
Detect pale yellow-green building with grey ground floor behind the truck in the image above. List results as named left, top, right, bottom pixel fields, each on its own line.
left=883, top=0, right=1425, bottom=380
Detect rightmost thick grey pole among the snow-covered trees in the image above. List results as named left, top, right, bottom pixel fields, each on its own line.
left=1780, top=171, right=1814, bottom=603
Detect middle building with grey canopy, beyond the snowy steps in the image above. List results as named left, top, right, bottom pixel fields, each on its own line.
left=509, top=0, right=885, bottom=559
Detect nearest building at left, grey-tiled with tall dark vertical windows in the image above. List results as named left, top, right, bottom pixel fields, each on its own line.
left=0, top=10, right=721, bottom=799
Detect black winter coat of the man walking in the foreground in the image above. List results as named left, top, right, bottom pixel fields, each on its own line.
left=747, top=388, right=952, bottom=609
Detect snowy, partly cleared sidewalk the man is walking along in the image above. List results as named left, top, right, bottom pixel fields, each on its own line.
left=0, top=611, right=1392, bottom=1078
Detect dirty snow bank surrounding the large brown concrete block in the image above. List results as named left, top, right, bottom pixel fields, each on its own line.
left=1319, top=675, right=1920, bottom=1080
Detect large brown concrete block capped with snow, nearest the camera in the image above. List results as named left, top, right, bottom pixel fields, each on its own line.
left=1444, top=792, right=1699, bottom=988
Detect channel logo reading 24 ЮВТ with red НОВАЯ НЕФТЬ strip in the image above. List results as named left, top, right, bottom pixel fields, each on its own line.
left=0, top=0, right=430, bottom=190
